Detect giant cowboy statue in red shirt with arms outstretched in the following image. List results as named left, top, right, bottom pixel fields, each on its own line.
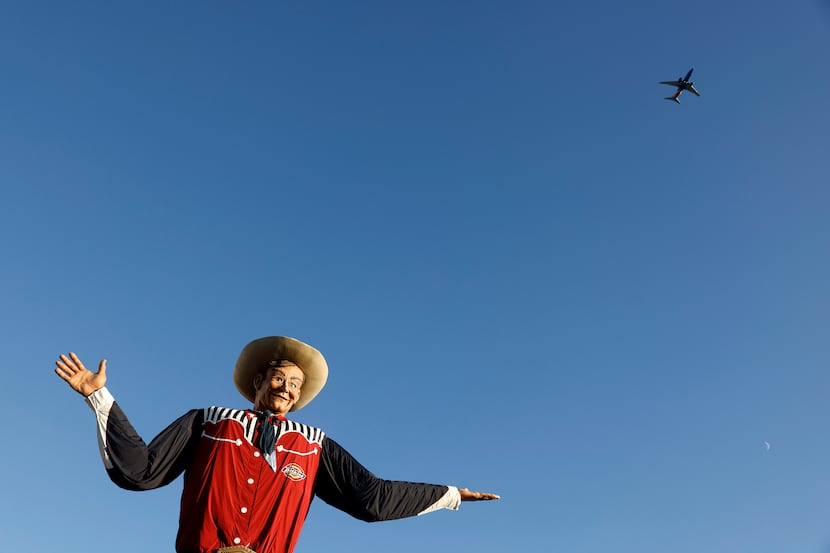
left=55, top=336, right=499, bottom=553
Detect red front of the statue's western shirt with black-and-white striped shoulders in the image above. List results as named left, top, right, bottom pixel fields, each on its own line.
left=176, top=407, right=323, bottom=552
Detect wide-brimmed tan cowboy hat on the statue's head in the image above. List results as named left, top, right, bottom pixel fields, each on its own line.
left=233, top=336, right=329, bottom=411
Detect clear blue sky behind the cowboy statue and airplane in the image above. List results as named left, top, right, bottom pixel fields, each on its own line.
left=0, top=0, right=830, bottom=553
